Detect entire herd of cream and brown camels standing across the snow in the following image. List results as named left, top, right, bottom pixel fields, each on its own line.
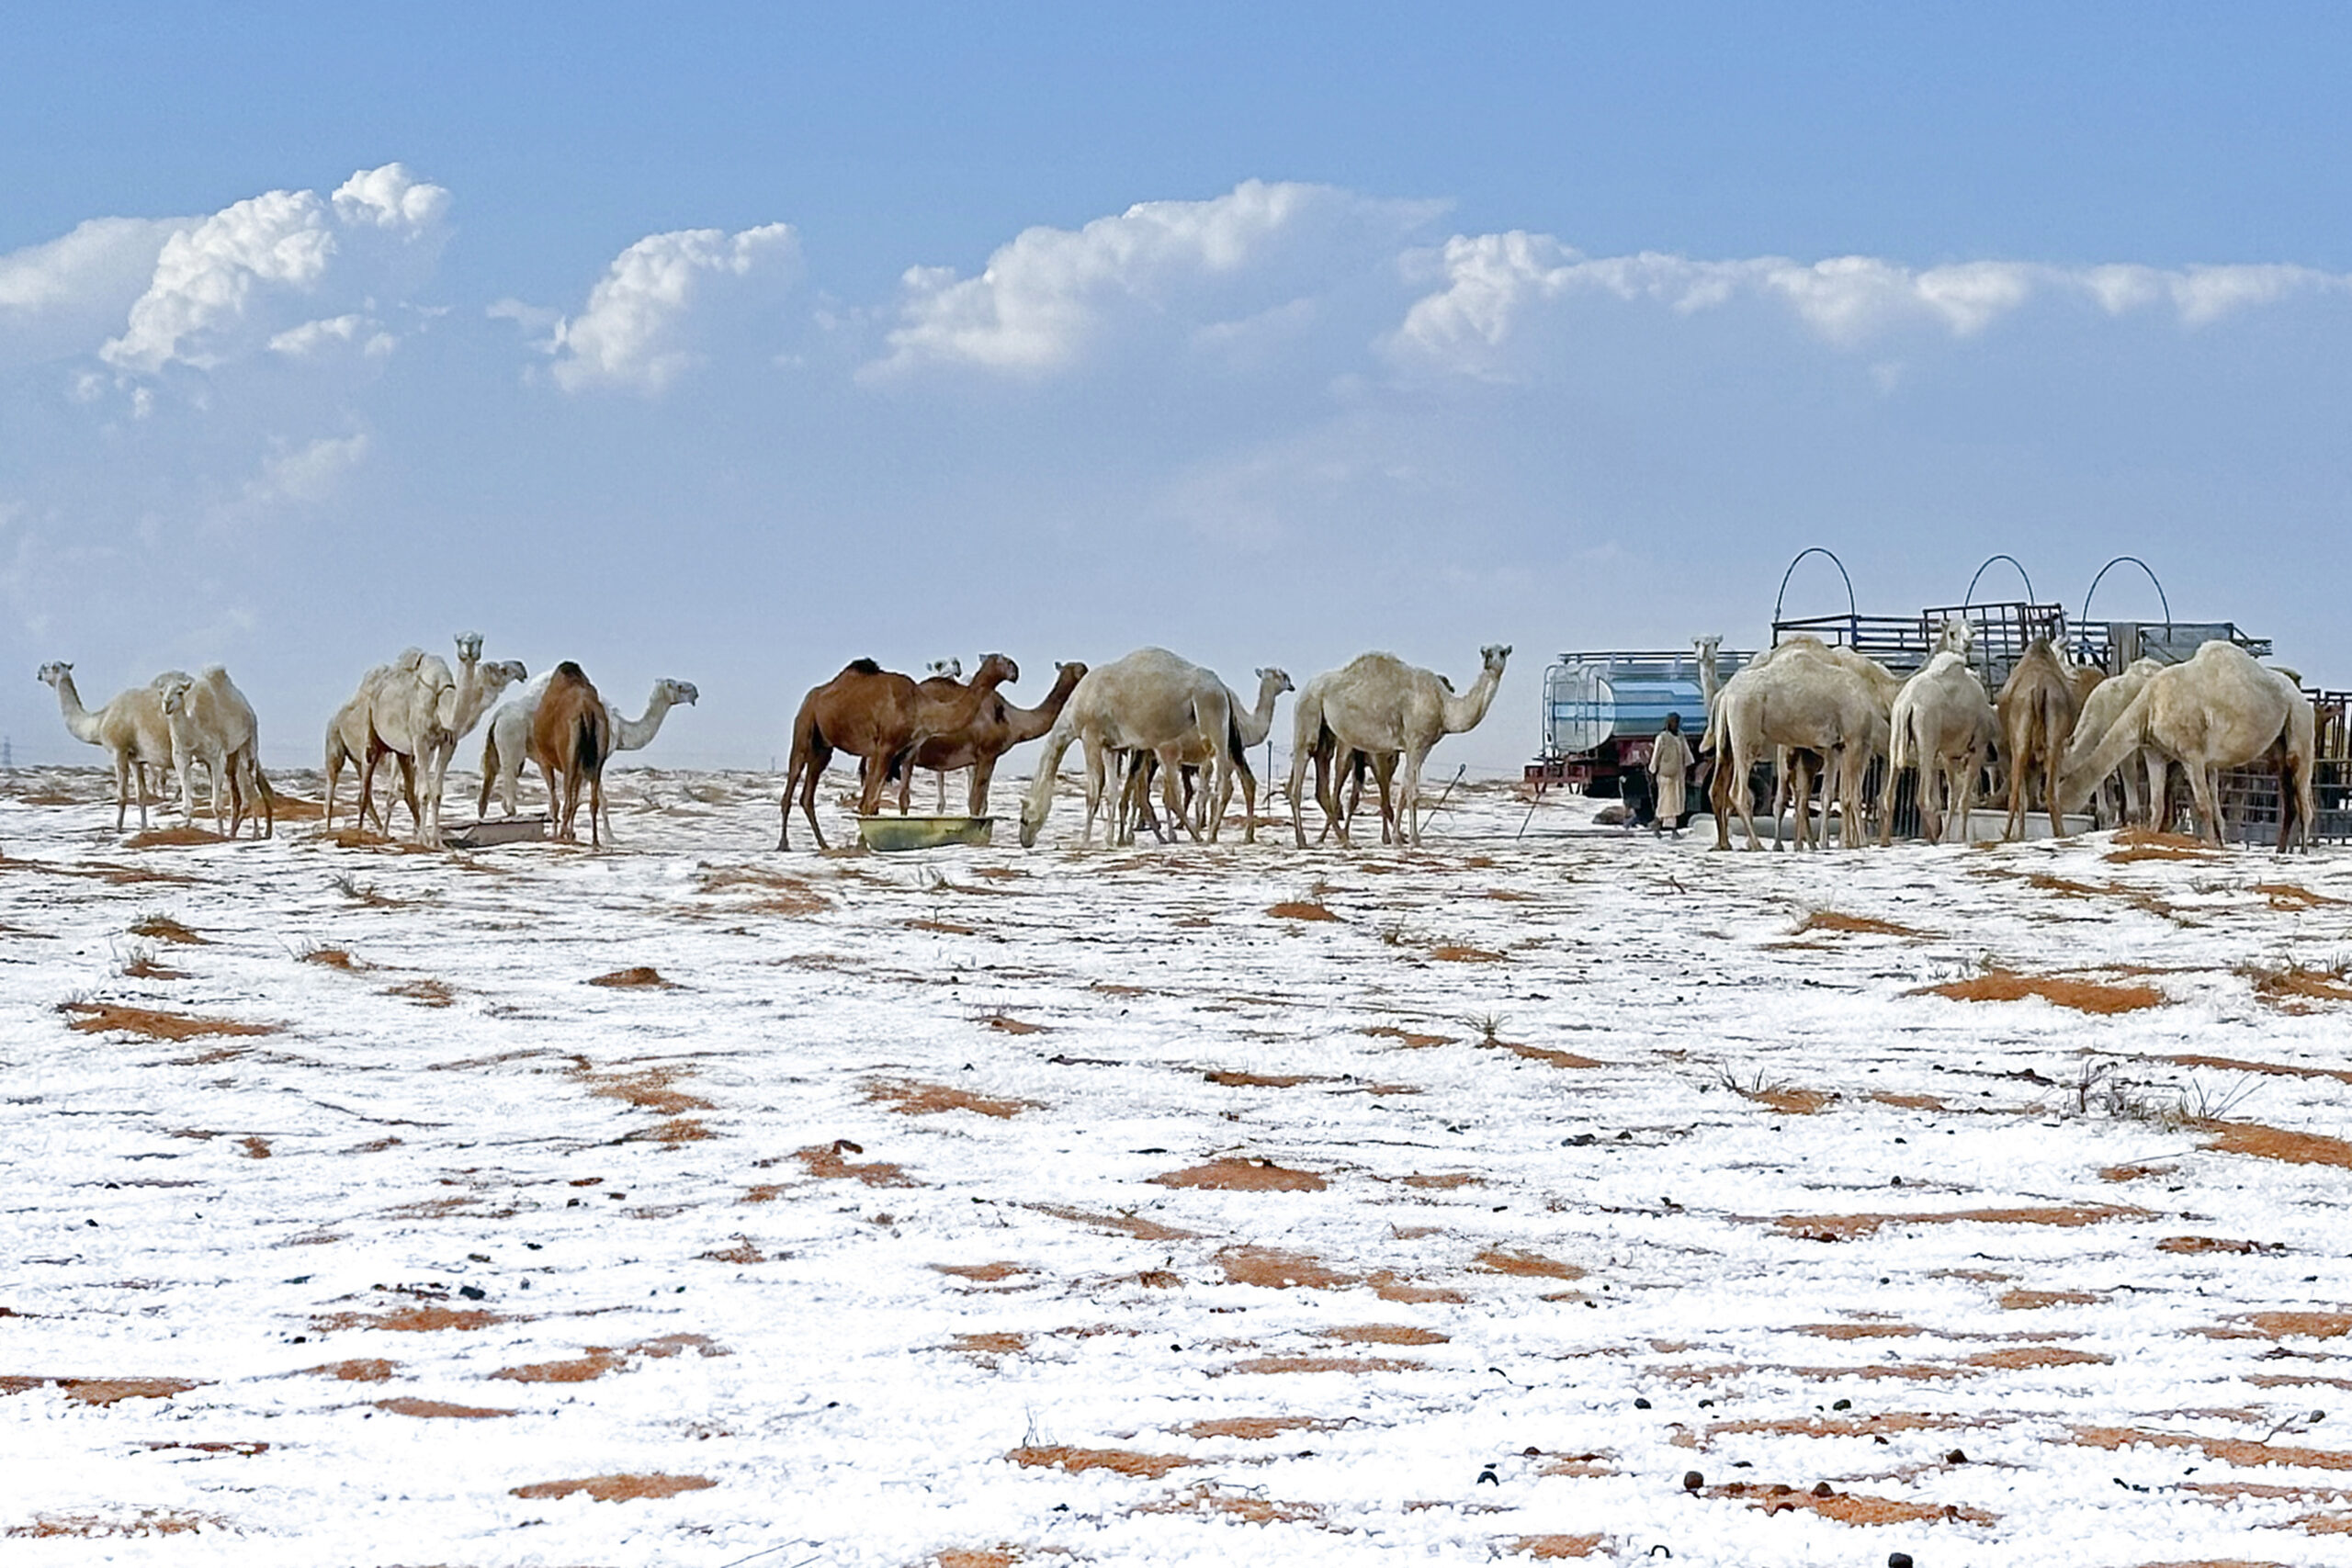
left=40, top=618, right=2314, bottom=851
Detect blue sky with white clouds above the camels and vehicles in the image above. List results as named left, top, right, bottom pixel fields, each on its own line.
left=0, top=5, right=2352, bottom=766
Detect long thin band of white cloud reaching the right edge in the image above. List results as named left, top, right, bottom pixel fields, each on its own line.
left=1383, top=232, right=2352, bottom=376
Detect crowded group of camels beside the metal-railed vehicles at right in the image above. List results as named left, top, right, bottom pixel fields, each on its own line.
left=1698, top=618, right=2317, bottom=851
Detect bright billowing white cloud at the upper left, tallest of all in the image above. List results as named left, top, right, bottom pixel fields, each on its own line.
left=99, top=164, right=449, bottom=376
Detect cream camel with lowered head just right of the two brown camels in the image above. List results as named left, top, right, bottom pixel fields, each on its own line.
left=1021, top=649, right=1235, bottom=849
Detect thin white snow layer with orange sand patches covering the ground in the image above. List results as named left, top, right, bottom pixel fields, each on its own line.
left=0, top=771, right=2352, bottom=1568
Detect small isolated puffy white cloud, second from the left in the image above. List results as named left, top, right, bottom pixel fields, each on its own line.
left=545, top=223, right=799, bottom=392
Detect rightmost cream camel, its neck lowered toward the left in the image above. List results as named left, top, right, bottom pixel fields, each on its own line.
left=2051, top=642, right=2317, bottom=853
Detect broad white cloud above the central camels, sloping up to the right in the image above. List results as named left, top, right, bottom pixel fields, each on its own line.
left=875, top=181, right=1442, bottom=376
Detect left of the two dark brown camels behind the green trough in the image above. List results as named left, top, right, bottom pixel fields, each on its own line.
left=776, top=653, right=1021, bottom=849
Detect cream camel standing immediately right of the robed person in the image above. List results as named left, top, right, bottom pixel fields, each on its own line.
left=1705, top=637, right=1900, bottom=849
